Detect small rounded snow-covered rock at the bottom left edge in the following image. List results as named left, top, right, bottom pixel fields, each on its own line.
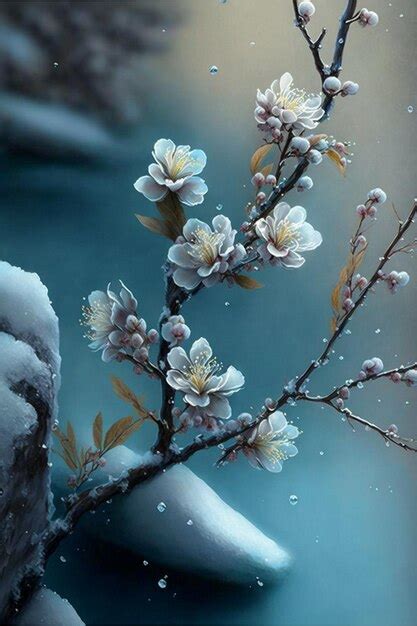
left=14, top=588, right=85, bottom=626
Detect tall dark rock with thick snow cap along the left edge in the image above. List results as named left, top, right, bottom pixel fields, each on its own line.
left=0, top=262, right=60, bottom=616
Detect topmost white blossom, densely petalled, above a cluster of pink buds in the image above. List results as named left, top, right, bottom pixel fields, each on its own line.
left=255, top=72, right=324, bottom=138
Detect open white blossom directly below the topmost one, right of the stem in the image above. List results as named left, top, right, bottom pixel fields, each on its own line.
left=255, top=202, right=322, bottom=268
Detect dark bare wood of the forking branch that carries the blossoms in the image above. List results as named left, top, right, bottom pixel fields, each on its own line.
left=33, top=0, right=417, bottom=584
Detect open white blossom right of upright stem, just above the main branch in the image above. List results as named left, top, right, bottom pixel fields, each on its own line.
left=167, top=337, right=245, bottom=419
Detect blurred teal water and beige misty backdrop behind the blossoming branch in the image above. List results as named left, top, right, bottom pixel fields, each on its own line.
left=0, top=0, right=417, bottom=626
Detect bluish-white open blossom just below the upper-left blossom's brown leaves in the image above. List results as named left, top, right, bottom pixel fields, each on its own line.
left=168, top=215, right=246, bottom=290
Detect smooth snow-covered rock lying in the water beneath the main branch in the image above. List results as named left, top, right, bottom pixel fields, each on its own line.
left=53, top=446, right=291, bottom=584
